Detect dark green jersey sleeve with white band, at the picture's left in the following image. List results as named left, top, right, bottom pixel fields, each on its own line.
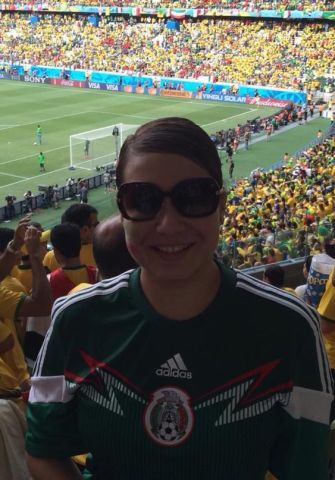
left=26, top=310, right=86, bottom=458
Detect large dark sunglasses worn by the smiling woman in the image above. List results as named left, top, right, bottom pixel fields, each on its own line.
left=117, top=177, right=221, bottom=222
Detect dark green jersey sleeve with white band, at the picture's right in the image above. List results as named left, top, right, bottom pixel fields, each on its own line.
left=269, top=309, right=334, bottom=480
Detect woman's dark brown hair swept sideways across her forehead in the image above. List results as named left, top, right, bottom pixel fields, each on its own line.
left=116, top=117, right=223, bottom=187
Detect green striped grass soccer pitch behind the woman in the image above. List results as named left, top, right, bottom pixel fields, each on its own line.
left=0, top=80, right=278, bottom=205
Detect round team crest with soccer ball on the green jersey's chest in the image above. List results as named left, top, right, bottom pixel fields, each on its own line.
left=144, top=387, right=194, bottom=447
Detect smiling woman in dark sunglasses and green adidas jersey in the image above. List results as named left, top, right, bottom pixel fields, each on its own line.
left=27, top=118, right=332, bottom=480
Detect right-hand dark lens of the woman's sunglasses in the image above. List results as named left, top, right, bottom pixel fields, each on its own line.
left=173, top=178, right=219, bottom=217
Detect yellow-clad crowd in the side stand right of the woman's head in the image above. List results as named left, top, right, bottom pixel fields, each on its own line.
left=218, top=136, right=335, bottom=268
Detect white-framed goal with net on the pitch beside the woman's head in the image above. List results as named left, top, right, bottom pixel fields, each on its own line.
left=69, top=123, right=139, bottom=170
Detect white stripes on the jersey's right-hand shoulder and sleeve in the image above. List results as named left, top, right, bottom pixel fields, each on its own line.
left=236, top=272, right=333, bottom=393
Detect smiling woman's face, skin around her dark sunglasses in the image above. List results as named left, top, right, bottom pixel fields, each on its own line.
left=123, top=153, right=225, bottom=282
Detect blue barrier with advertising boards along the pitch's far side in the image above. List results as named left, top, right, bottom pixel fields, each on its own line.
left=0, top=70, right=307, bottom=107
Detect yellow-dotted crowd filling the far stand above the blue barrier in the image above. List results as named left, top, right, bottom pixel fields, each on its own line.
left=0, top=13, right=335, bottom=89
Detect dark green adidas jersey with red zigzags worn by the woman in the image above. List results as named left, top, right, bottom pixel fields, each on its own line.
left=27, top=266, right=332, bottom=480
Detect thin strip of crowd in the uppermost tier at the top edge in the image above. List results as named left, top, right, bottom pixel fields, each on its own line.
left=2, top=0, right=334, bottom=12
